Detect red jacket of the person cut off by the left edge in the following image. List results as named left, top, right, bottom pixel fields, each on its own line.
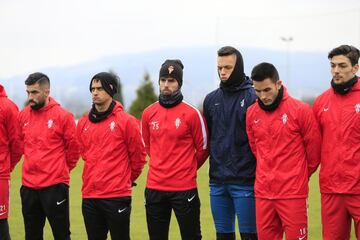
left=0, top=85, right=23, bottom=180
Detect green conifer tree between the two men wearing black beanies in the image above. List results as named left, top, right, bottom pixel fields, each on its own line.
left=129, top=72, right=158, bottom=119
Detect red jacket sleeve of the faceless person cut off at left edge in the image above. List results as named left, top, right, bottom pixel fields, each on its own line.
left=7, top=104, right=24, bottom=172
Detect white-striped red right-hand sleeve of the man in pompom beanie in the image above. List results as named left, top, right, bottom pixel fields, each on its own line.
left=190, top=109, right=209, bottom=169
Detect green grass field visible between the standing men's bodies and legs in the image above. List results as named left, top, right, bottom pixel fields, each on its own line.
left=9, top=161, right=355, bottom=240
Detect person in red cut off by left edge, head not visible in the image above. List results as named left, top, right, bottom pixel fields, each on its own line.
left=0, top=85, right=23, bottom=240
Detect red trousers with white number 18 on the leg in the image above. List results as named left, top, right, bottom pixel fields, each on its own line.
left=256, top=198, right=308, bottom=240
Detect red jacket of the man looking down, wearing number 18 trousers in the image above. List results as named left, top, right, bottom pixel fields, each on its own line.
left=246, top=88, right=321, bottom=199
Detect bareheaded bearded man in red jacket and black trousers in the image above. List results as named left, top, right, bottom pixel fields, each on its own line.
left=19, top=72, right=79, bottom=240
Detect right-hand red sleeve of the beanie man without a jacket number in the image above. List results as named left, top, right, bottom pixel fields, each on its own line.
left=125, top=116, right=146, bottom=182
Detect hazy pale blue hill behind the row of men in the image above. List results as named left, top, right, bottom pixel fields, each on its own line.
left=0, top=47, right=331, bottom=115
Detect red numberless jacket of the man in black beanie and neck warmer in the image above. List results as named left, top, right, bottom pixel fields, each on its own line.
left=77, top=102, right=146, bottom=198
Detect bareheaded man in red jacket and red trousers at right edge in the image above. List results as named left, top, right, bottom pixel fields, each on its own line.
left=313, top=45, right=360, bottom=240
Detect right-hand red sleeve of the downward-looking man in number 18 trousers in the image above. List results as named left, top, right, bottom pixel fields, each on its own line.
left=299, top=106, right=321, bottom=178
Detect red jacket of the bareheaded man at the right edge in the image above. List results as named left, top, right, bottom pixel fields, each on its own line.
left=313, top=78, right=360, bottom=194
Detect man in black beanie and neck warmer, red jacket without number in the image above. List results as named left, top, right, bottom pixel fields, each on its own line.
left=77, top=72, right=146, bottom=240
